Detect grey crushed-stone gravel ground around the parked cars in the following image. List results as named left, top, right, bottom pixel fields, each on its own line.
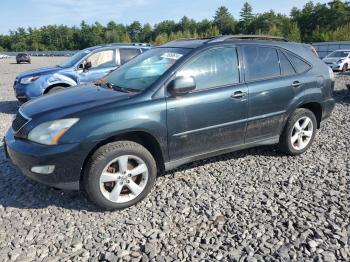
left=0, top=58, right=350, bottom=261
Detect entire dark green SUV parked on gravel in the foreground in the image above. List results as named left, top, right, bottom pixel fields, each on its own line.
left=5, top=36, right=334, bottom=209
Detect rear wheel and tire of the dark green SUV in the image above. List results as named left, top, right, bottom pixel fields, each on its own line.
left=279, top=108, right=317, bottom=156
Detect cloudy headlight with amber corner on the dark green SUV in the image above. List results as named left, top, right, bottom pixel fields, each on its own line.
left=28, top=118, right=79, bottom=145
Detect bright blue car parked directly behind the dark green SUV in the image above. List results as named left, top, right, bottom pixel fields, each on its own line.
left=14, top=44, right=151, bottom=102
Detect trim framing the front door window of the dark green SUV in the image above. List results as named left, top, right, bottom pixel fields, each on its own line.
left=172, top=44, right=242, bottom=94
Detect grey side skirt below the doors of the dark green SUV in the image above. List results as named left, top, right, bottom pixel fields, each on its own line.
left=164, top=135, right=280, bottom=171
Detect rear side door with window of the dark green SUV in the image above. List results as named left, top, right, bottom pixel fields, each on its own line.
left=242, top=45, right=303, bottom=143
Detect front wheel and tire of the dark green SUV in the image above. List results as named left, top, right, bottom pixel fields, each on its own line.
left=82, top=141, right=157, bottom=210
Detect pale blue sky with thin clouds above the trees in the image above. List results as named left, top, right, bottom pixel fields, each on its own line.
left=0, top=0, right=329, bottom=34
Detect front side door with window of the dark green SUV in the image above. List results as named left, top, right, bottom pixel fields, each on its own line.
left=167, top=46, right=248, bottom=160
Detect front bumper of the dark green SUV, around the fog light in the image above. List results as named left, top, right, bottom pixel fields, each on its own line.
left=4, top=128, right=87, bottom=190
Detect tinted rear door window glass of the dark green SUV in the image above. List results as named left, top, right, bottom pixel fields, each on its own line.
left=243, top=46, right=281, bottom=81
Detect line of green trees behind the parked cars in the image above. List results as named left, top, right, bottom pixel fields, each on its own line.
left=0, top=0, right=350, bottom=51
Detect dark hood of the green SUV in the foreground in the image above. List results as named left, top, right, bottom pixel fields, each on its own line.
left=21, top=84, right=134, bottom=119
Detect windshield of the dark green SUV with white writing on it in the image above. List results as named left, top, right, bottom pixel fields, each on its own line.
left=106, top=48, right=190, bottom=92
